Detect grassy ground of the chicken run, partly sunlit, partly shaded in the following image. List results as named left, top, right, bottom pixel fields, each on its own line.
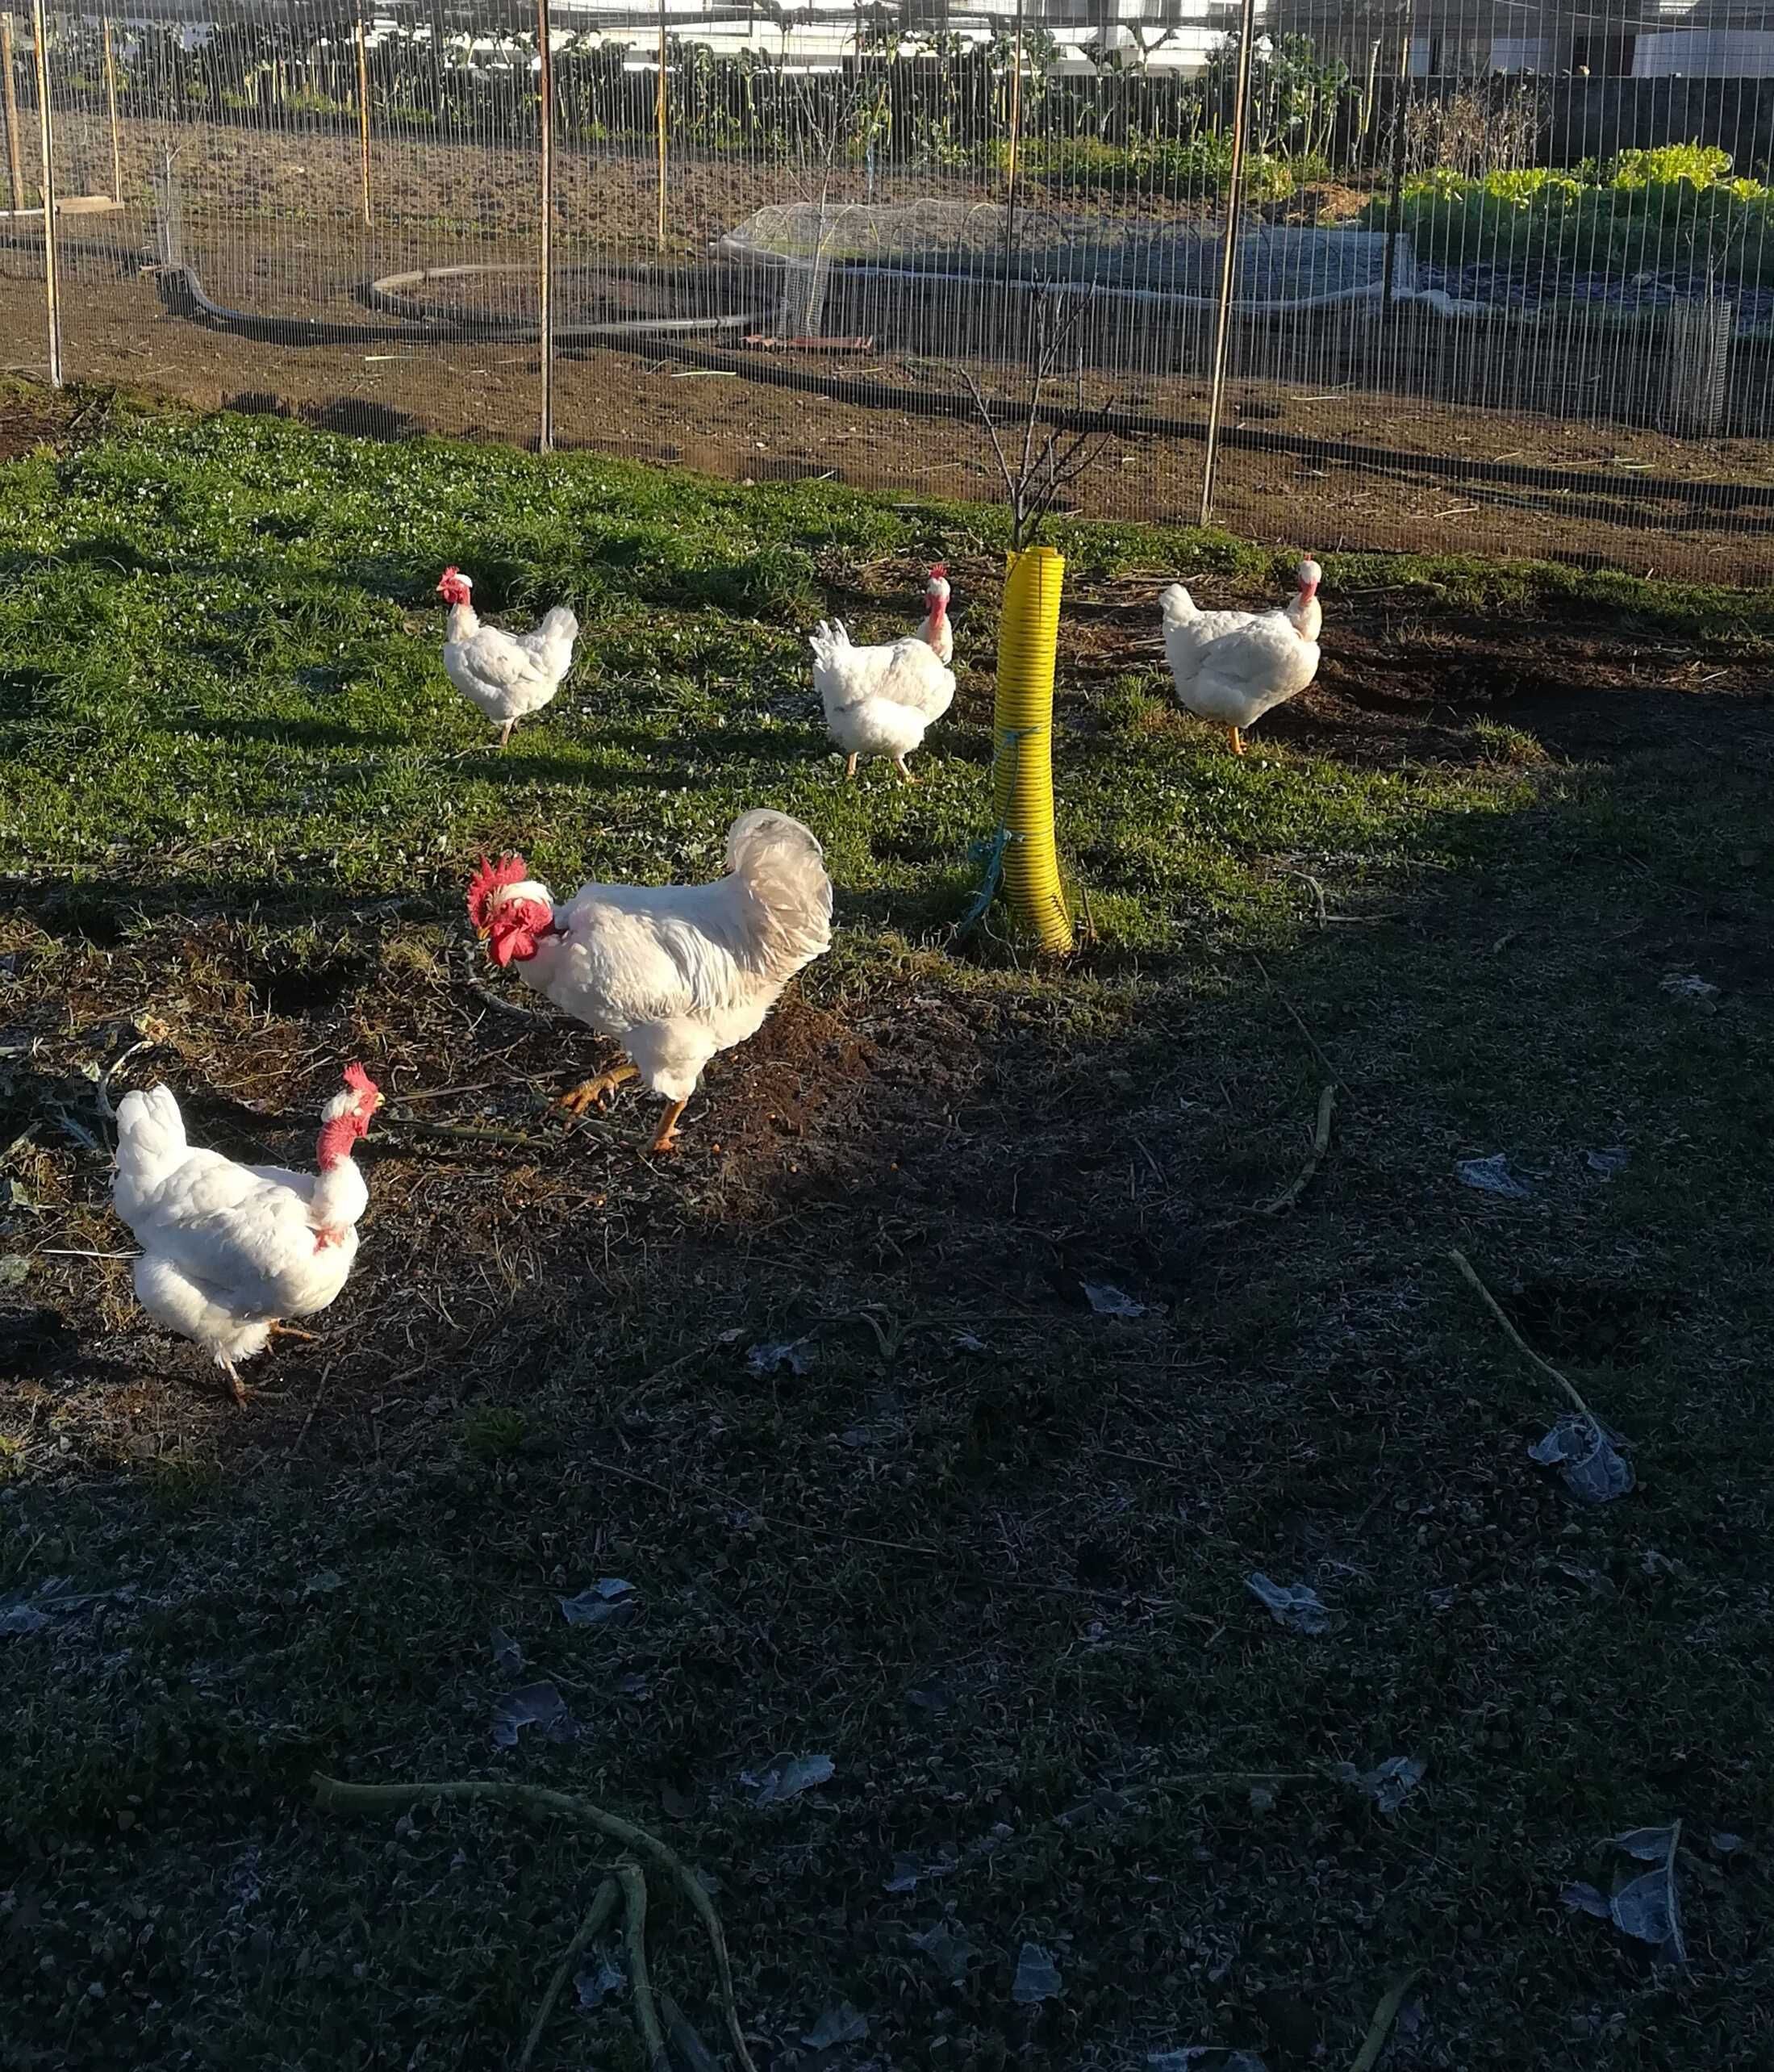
left=0, top=391, right=1774, bottom=2072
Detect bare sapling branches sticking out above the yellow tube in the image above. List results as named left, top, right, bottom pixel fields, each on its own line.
left=962, top=276, right=1111, bottom=554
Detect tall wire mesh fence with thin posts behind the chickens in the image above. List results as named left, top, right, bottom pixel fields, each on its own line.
left=0, top=0, right=1774, bottom=580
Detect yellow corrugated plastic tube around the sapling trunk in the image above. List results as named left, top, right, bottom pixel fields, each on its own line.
left=993, top=547, right=1071, bottom=951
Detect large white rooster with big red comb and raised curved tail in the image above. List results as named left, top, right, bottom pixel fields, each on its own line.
left=469, top=810, right=831, bottom=1152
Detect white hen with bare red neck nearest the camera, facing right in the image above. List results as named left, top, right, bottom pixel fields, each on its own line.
left=112, top=1065, right=382, bottom=1403
